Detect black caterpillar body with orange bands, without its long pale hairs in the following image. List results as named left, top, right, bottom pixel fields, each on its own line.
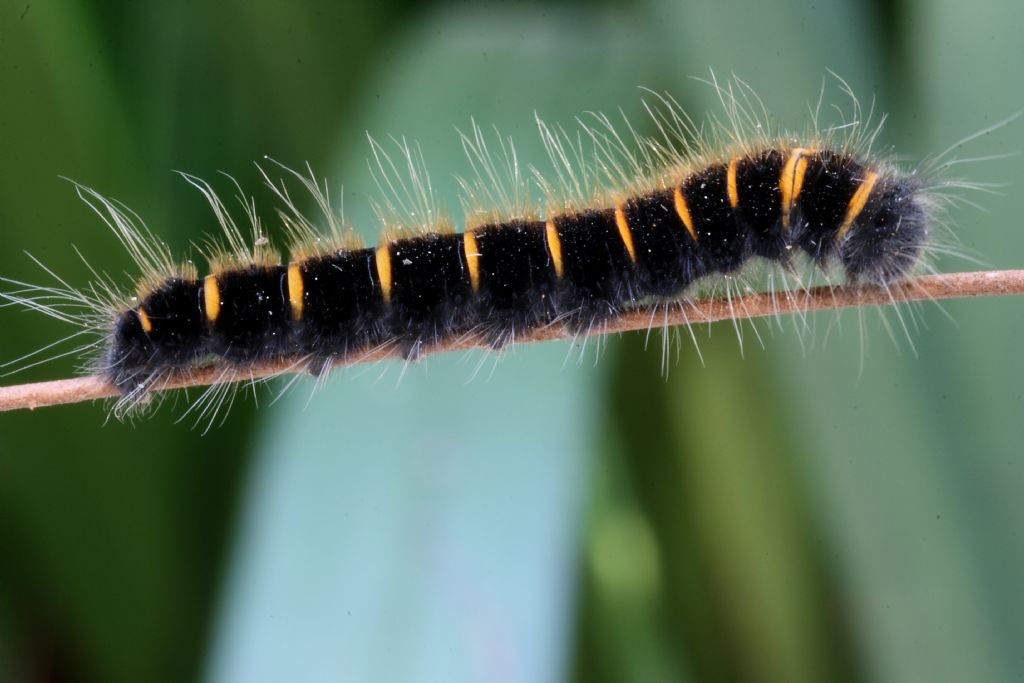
left=110, top=146, right=930, bottom=398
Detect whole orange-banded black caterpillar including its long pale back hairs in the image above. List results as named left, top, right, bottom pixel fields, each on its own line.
left=3, top=81, right=966, bottom=416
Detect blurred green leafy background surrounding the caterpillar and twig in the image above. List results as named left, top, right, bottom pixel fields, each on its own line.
left=0, top=0, right=1024, bottom=681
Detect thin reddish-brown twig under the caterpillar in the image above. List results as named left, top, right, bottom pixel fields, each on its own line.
left=0, top=270, right=1024, bottom=412
